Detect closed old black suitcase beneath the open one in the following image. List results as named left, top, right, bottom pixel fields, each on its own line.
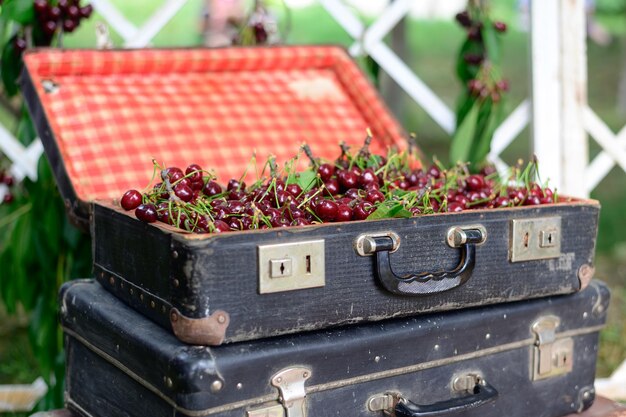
left=61, top=281, right=609, bottom=417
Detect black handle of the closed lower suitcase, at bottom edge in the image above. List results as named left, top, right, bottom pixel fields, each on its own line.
left=393, top=381, right=498, bottom=417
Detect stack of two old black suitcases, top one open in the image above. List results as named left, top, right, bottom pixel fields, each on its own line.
left=22, top=47, right=609, bottom=417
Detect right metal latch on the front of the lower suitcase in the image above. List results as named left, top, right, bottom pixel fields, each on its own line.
left=532, top=316, right=574, bottom=381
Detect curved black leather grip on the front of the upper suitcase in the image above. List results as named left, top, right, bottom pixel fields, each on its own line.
left=373, top=229, right=484, bottom=296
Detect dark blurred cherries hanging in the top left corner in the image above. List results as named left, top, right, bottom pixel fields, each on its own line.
left=13, top=0, right=93, bottom=54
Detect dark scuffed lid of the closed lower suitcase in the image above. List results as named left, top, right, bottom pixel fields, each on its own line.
left=60, top=280, right=609, bottom=416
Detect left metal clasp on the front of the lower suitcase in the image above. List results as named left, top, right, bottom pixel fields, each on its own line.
left=271, top=367, right=311, bottom=417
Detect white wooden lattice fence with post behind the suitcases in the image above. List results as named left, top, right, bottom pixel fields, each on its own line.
left=0, top=0, right=626, bottom=398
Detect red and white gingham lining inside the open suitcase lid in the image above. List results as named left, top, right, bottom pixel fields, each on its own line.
left=24, top=47, right=405, bottom=201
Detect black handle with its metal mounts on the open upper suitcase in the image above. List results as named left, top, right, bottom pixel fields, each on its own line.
left=357, top=226, right=487, bottom=296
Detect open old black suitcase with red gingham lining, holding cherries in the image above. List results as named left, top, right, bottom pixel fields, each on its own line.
left=22, top=47, right=599, bottom=345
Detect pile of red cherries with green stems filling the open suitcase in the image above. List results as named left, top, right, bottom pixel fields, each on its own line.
left=120, top=142, right=558, bottom=233
